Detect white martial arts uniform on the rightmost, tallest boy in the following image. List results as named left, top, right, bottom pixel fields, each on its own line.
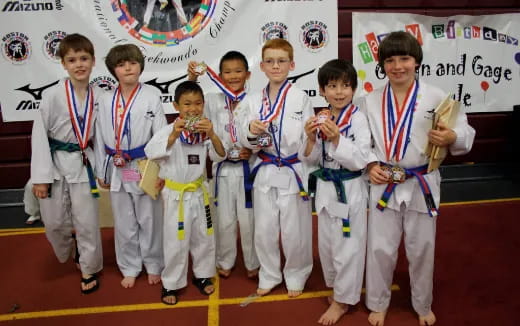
left=360, top=82, right=475, bottom=316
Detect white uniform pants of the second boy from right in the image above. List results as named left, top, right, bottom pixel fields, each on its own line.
left=318, top=201, right=367, bottom=305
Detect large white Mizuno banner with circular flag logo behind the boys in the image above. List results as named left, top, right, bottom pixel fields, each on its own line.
left=0, top=0, right=338, bottom=121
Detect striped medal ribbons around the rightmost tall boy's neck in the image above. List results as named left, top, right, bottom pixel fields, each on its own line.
left=381, top=80, right=419, bottom=162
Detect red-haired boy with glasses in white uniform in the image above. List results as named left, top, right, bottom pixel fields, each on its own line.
left=242, top=39, right=314, bottom=297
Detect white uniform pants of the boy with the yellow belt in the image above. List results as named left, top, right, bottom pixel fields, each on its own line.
left=161, top=188, right=215, bottom=290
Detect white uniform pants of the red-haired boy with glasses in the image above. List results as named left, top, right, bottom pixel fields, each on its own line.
left=253, top=188, right=312, bottom=291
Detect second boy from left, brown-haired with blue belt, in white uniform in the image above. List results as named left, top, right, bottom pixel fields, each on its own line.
left=96, top=44, right=166, bottom=288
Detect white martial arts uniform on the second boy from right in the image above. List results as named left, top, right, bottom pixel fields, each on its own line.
left=300, top=110, right=370, bottom=305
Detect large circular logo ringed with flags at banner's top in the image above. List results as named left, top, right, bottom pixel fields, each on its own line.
left=110, top=0, right=217, bottom=47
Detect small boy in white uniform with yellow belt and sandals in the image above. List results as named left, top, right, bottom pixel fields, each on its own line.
left=145, top=81, right=226, bottom=305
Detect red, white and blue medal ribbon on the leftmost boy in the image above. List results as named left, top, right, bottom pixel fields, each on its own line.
left=65, top=79, right=94, bottom=150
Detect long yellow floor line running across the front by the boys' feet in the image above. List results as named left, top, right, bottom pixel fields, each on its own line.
left=0, top=281, right=400, bottom=320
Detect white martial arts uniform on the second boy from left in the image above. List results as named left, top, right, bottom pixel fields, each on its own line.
left=96, top=84, right=166, bottom=277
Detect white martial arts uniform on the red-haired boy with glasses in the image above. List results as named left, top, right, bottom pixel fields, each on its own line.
left=240, top=86, right=314, bottom=291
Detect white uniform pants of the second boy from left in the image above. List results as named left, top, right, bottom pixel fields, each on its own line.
left=110, top=188, right=164, bottom=277
